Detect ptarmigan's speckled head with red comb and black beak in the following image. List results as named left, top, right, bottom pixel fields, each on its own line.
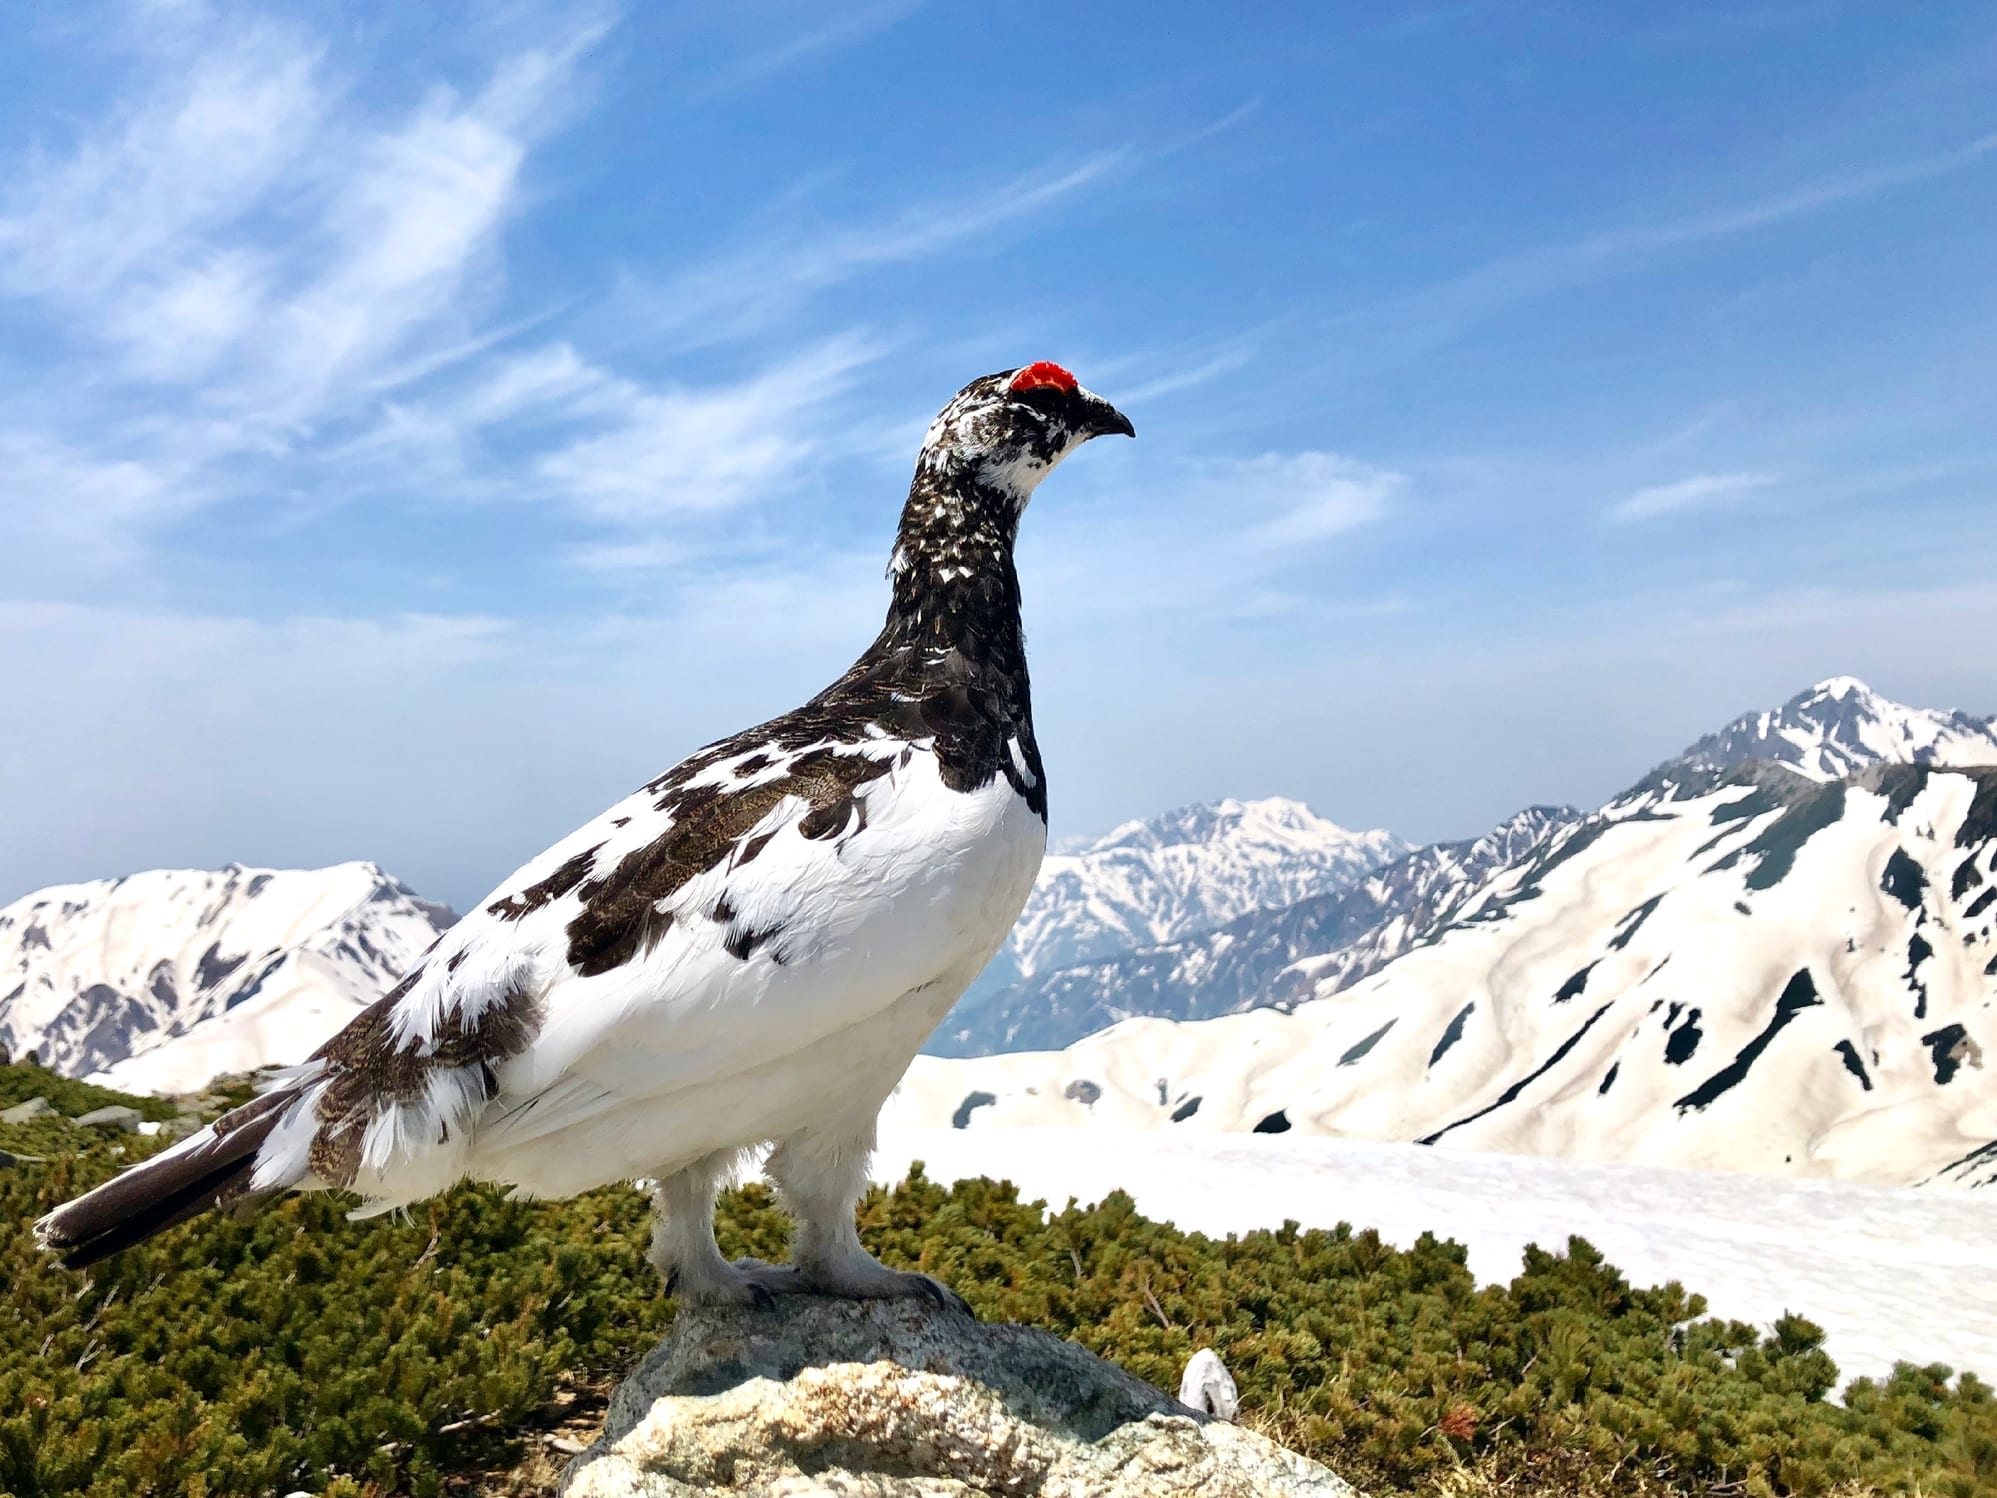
left=921, top=360, right=1136, bottom=509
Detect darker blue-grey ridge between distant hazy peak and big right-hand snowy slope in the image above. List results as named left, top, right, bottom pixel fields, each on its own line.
left=929, top=807, right=1582, bottom=1057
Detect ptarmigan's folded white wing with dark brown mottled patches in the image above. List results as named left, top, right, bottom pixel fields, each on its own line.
left=258, top=731, right=1038, bottom=1204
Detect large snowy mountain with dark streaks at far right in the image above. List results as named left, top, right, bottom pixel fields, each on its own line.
left=891, top=681, right=1997, bottom=1184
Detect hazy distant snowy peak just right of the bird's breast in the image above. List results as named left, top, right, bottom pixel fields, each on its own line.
left=993, top=797, right=1414, bottom=998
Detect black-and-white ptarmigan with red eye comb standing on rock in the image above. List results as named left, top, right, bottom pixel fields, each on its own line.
left=38, top=362, right=1134, bottom=1300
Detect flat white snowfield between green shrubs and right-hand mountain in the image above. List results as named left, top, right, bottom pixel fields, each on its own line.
left=875, top=1128, right=1997, bottom=1378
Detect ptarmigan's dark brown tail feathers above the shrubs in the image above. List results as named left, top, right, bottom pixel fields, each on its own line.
left=34, top=1087, right=300, bottom=1268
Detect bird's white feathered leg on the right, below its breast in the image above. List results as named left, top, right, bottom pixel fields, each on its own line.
left=763, top=1111, right=971, bottom=1316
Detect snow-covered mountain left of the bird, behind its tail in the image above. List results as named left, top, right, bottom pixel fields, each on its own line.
left=0, top=863, right=455, bottom=1093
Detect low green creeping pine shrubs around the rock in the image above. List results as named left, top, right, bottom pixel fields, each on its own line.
left=0, top=1067, right=1997, bottom=1498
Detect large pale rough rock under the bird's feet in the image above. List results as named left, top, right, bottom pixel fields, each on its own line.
left=561, top=1296, right=1356, bottom=1498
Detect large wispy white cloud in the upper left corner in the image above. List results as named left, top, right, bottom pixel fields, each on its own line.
left=0, top=10, right=601, bottom=559
